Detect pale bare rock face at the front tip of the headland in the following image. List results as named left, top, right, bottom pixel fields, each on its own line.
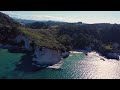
left=33, top=46, right=62, bottom=65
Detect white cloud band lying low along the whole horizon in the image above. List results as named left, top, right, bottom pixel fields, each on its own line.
left=2, top=11, right=120, bottom=23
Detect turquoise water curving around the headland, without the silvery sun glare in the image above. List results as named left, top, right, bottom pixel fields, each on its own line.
left=0, top=49, right=85, bottom=79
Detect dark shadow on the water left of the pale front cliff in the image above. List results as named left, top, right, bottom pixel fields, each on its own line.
left=15, top=53, right=41, bottom=72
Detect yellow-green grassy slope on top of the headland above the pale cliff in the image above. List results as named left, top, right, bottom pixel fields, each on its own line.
left=18, top=27, right=59, bottom=49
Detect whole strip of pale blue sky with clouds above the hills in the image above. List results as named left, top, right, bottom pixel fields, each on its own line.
left=0, top=11, right=120, bottom=24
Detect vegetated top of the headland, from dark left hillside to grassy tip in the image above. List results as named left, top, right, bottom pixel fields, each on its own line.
left=0, top=13, right=62, bottom=50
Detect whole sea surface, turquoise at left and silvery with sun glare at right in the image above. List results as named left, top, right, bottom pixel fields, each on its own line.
left=0, top=49, right=120, bottom=79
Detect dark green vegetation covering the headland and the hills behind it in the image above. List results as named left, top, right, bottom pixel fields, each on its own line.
left=0, top=13, right=120, bottom=52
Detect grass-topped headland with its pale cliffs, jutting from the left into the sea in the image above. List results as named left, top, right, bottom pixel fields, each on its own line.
left=0, top=13, right=69, bottom=66
